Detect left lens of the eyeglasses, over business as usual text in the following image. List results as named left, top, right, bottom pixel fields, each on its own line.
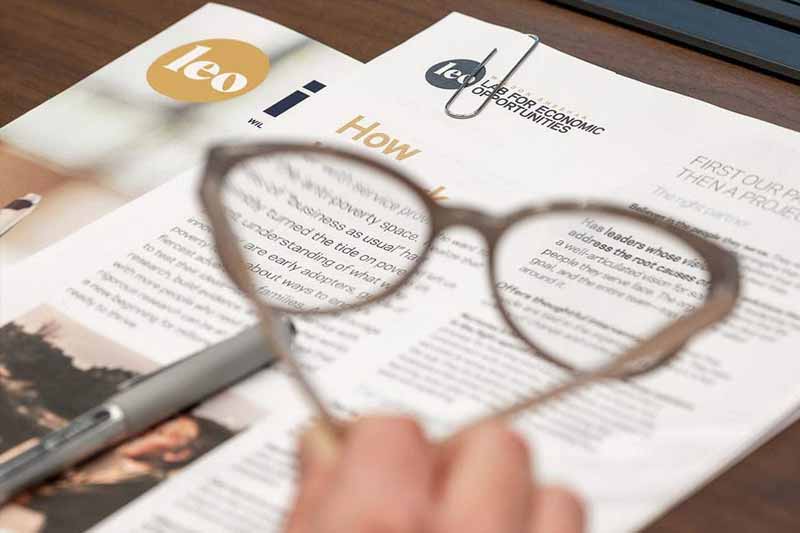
left=217, top=153, right=431, bottom=311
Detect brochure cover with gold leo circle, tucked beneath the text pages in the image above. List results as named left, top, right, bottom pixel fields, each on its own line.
left=0, top=4, right=360, bottom=266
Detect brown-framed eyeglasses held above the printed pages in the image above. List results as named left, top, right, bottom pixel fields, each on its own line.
left=201, top=144, right=739, bottom=436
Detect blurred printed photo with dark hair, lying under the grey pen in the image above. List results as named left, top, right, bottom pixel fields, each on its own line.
left=0, top=306, right=263, bottom=533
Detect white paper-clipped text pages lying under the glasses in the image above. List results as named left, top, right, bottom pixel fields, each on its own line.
left=0, top=10, right=800, bottom=533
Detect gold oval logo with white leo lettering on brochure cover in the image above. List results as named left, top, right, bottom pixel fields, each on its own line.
left=147, top=39, right=269, bottom=102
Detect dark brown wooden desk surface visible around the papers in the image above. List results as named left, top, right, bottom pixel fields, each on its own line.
left=0, top=0, right=800, bottom=533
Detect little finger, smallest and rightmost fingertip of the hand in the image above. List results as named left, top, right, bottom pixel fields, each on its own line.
left=529, top=487, right=586, bottom=533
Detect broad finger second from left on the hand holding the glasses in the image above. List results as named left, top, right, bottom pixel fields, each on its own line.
left=317, top=418, right=435, bottom=533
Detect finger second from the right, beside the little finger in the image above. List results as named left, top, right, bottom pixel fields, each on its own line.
left=434, top=422, right=533, bottom=533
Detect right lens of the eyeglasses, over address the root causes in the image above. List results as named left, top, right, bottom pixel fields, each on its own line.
left=495, top=210, right=709, bottom=370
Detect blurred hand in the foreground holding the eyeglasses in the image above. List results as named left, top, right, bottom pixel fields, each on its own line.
left=286, top=418, right=584, bottom=533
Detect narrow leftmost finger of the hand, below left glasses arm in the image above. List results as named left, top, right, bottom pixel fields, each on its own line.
left=285, top=423, right=341, bottom=533
